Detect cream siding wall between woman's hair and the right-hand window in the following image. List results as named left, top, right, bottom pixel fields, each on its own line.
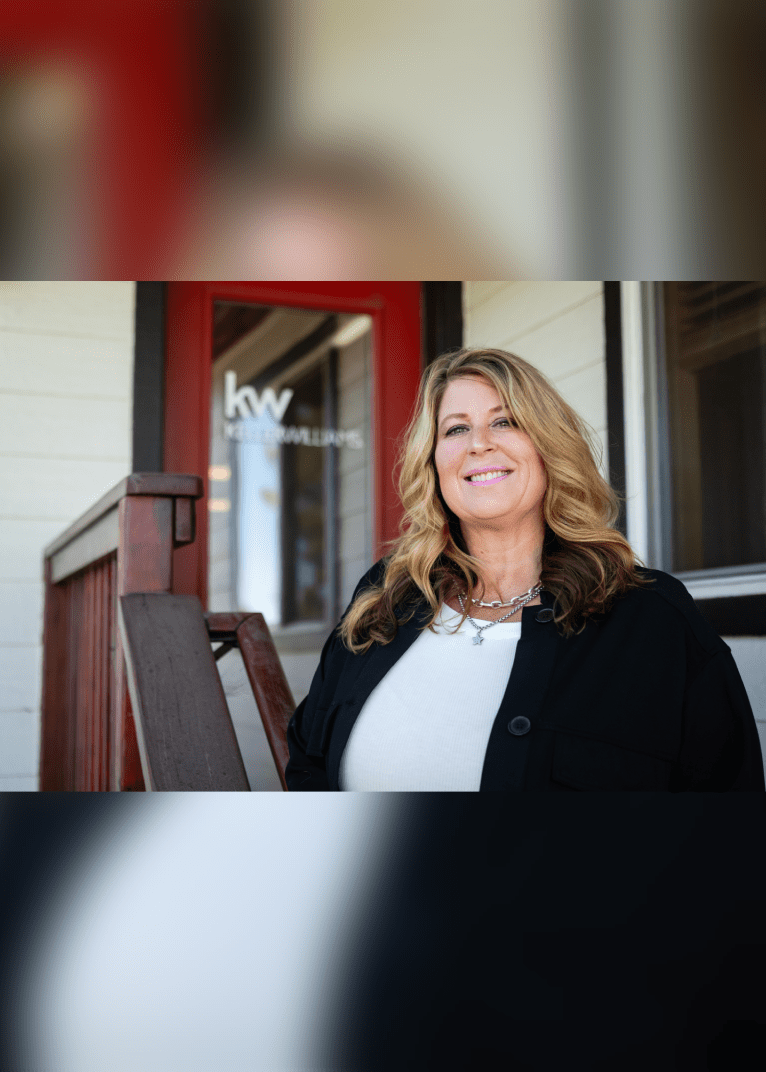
left=463, top=281, right=609, bottom=474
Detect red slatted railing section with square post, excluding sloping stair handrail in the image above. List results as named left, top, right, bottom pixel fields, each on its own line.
left=41, top=473, right=202, bottom=790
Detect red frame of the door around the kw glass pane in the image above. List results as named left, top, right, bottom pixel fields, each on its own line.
left=165, top=282, right=422, bottom=606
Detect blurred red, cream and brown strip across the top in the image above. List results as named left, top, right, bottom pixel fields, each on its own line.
left=0, top=0, right=766, bottom=279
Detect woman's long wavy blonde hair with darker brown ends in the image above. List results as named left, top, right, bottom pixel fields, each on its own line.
left=339, top=349, right=647, bottom=652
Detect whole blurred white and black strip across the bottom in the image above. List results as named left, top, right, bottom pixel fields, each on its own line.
left=0, top=792, right=766, bottom=1072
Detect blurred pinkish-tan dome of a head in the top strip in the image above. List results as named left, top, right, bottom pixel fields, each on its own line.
left=172, top=147, right=517, bottom=280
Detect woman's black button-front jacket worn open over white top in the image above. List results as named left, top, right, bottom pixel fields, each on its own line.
left=286, top=560, right=765, bottom=792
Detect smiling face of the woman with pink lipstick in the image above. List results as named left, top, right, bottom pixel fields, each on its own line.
left=434, top=376, right=547, bottom=534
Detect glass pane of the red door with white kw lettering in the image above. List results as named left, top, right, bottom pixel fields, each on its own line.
left=208, top=301, right=372, bottom=634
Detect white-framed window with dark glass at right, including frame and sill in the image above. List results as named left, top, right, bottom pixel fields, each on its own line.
left=607, top=282, right=766, bottom=637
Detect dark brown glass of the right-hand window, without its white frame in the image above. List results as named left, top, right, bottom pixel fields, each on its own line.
left=659, top=282, right=766, bottom=572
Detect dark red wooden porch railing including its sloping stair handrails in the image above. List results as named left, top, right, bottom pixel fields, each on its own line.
left=41, top=473, right=295, bottom=791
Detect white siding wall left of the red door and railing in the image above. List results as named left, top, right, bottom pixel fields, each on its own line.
left=0, top=282, right=135, bottom=790
